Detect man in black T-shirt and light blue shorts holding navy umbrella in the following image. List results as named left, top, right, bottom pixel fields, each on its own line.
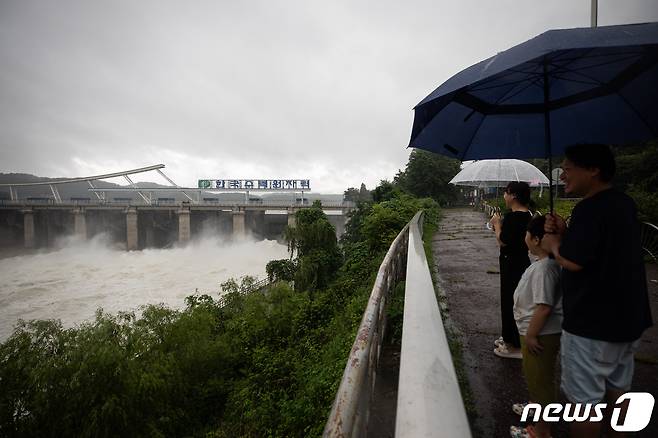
left=542, top=144, right=652, bottom=437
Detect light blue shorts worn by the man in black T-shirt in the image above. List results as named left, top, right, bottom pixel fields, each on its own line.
left=560, top=330, right=640, bottom=403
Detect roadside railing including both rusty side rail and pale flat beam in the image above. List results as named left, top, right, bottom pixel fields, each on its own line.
left=324, top=212, right=471, bottom=438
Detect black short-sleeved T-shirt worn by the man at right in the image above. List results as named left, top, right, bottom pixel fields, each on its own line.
left=560, top=189, right=652, bottom=342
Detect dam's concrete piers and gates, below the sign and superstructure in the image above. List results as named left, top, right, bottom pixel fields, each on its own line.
left=0, top=200, right=349, bottom=250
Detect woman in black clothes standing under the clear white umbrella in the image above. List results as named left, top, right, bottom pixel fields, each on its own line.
left=491, top=182, right=531, bottom=359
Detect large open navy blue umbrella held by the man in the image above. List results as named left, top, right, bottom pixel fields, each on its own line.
left=409, top=23, right=658, bottom=210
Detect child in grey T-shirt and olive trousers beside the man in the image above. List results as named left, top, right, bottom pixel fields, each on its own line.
left=510, top=216, right=562, bottom=438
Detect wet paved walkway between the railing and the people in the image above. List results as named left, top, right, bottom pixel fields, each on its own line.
left=432, top=209, right=658, bottom=437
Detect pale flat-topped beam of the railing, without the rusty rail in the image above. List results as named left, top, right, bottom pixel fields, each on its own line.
left=395, top=215, right=471, bottom=438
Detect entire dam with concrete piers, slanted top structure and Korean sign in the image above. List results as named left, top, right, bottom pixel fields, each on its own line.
left=0, top=164, right=354, bottom=251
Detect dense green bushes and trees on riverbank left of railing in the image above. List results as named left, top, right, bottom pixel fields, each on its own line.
left=0, top=187, right=438, bottom=437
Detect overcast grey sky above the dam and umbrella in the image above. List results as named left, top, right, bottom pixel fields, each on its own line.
left=0, top=0, right=658, bottom=193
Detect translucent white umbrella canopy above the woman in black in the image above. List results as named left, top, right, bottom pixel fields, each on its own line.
left=450, top=159, right=548, bottom=187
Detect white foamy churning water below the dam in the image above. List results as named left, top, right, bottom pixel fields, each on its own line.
left=0, top=236, right=287, bottom=342
